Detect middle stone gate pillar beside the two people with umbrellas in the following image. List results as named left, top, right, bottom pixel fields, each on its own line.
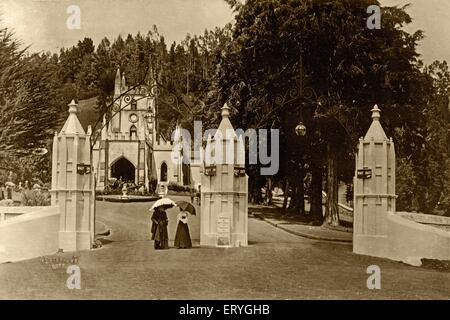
left=200, top=104, right=248, bottom=247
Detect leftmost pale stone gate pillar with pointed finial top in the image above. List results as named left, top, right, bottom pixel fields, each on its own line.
left=51, top=100, right=94, bottom=251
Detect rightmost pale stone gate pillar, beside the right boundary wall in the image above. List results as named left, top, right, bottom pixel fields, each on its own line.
left=353, top=105, right=396, bottom=256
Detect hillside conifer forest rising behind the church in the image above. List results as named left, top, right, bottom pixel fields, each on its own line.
left=59, top=25, right=231, bottom=136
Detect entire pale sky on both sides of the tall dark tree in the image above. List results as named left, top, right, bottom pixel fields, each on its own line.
left=0, top=0, right=450, bottom=63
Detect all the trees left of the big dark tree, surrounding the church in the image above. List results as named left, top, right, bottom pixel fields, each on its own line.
left=0, top=25, right=231, bottom=182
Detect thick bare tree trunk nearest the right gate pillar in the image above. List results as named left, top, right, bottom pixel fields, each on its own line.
left=325, top=143, right=339, bottom=226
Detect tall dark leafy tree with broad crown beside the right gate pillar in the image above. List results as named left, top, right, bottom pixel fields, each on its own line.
left=219, top=0, right=426, bottom=224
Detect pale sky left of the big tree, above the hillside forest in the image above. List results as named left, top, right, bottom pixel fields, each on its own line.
left=0, top=0, right=234, bottom=52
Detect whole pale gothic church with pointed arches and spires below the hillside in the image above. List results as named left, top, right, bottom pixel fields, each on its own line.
left=93, top=70, right=199, bottom=190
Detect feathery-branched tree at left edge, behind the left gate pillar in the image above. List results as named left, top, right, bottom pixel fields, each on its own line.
left=0, top=28, right=68, bottom=183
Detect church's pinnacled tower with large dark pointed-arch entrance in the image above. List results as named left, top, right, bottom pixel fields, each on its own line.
left=96, top=69, right=154, bottom=189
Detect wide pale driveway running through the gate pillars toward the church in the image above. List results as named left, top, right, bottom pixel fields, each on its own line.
left=0, top=198, right=450, bottom=299
